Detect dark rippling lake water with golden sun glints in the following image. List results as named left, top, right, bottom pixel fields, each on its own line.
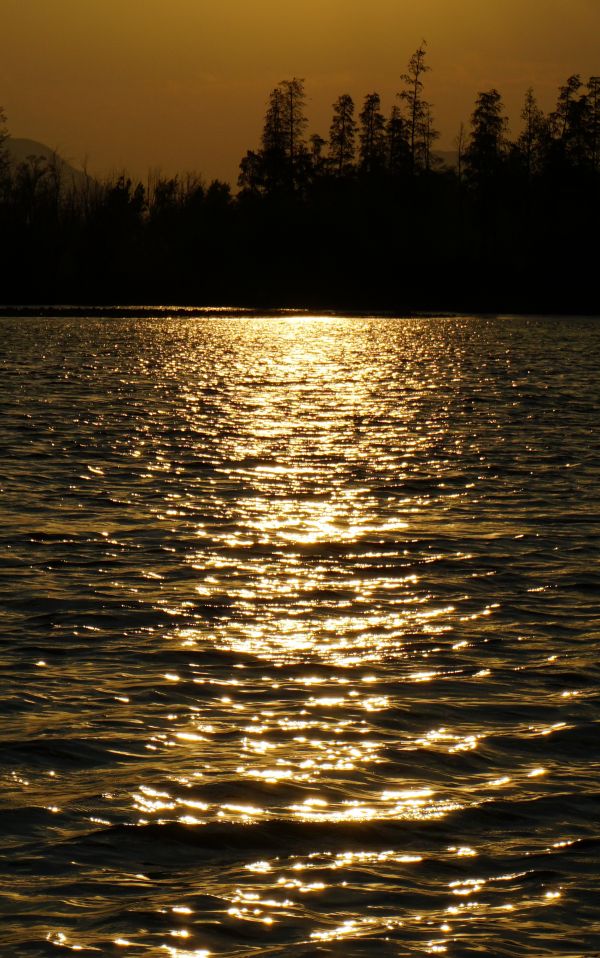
left=0, top=316, right=600, bottom=958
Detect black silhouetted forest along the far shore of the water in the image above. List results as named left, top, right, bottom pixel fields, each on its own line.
left=0, top=43, right=600, bottom=312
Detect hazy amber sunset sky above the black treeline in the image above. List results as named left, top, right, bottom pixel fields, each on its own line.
left=0, top=0, right=600, bottom=183
